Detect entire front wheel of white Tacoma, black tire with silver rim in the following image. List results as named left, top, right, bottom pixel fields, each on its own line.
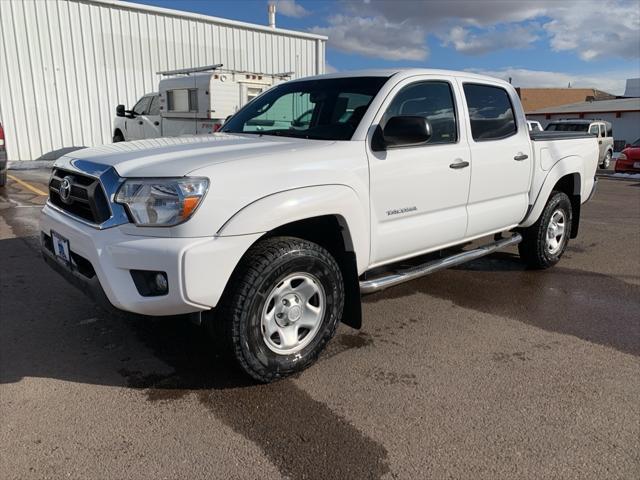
left=211, top=237, right=344, bottom=382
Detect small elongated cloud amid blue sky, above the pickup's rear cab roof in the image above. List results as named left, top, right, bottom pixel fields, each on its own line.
left=441, top=26, right=538, bottom=55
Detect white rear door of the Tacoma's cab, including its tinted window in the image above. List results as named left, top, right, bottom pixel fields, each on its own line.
left=458, top=79, right=532, bottom=238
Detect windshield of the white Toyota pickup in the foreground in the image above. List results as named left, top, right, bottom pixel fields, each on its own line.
left=221, top=77, right=387, bottom=140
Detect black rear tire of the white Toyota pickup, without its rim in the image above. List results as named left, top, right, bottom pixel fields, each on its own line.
left=518, top=191, right=573, bottom=269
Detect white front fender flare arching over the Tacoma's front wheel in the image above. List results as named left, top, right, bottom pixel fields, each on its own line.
left=216, top=184, right=370, bottom=274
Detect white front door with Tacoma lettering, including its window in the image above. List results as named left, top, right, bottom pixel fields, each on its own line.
left=368, top=75, right=471, bottom=266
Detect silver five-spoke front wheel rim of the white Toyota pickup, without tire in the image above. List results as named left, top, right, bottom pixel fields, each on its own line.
left=262, top=272, right=326, bottom=355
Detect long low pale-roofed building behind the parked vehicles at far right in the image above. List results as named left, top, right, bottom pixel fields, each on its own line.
left=527, top=97, right=640, bottom=151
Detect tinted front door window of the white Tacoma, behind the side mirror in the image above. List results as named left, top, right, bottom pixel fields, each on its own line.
left=381, top=81, right=458, bottom=144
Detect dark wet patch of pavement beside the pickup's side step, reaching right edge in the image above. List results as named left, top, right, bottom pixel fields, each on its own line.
left=365, top=253, right=640, bottom=356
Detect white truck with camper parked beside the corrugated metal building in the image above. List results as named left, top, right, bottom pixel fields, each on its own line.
left=113, top=64, right=293, bottom=142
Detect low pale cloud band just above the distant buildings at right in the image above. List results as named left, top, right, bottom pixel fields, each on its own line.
left=469, top=67, right=639, bottom=95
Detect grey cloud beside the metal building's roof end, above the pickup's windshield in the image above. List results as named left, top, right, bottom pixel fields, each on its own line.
left=311, top=15, right=429, bottom=60
